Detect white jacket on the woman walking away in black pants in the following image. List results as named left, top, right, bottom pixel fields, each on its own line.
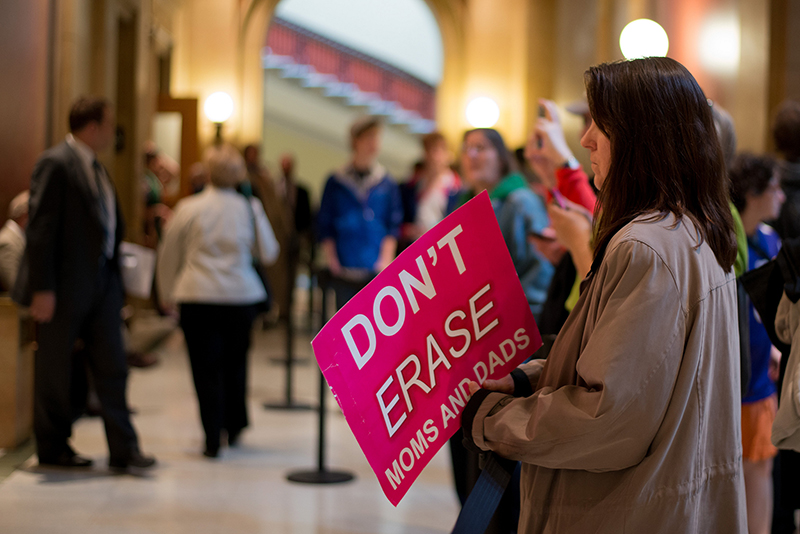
left=157, top=185, right=280, bottom=305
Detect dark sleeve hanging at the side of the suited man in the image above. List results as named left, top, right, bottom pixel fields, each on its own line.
left=25, top=158, right=67, bottom=292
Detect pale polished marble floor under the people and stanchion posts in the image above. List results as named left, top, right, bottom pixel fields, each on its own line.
left=0, top=320, right=458, bottom=534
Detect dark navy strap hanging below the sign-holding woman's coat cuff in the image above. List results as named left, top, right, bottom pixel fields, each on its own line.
left=453, top=452, right=517, bottom=534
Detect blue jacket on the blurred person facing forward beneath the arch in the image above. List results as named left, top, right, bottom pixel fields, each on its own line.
left=317, top=165, right=403, bottom=271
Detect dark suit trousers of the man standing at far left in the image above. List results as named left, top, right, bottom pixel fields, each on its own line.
left=34, top=263, right=139, bottom=461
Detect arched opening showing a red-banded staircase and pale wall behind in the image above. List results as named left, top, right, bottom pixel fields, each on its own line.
left=262, top=0, right=443, bottom=188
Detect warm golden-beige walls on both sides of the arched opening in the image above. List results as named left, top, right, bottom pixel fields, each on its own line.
left=0, top=0, right=800, bottom=228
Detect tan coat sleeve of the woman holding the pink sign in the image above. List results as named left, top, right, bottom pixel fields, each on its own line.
left=472, top=242, right=685, bottom=472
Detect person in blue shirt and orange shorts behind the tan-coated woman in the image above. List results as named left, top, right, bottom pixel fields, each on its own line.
left=728, top=153, right=786, bottom=534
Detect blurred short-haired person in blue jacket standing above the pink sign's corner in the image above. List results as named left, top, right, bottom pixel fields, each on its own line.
left=317, top=116, right=403, bottom=309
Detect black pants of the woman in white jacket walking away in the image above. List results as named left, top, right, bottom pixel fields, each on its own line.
left=181, top=303, right=256, bottom=452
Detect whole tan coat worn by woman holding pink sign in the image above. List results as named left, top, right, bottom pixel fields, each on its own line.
left=472, top=215, right=747, bottom=534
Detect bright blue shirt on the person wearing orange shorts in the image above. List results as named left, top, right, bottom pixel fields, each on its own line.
left=742, top=224, right=781, bottom=404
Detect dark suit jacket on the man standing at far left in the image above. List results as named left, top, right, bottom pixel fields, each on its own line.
left=12, top=142, right=125, bottom=306
